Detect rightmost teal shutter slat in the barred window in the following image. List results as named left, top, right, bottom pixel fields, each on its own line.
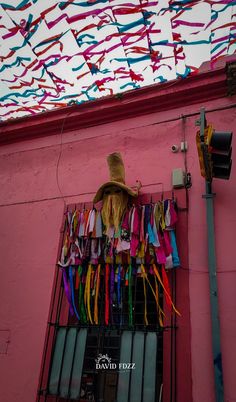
left=143, top=332, right=157, bottom=402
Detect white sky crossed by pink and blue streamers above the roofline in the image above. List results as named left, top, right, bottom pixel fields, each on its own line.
left=0, top=0, right=236, bottom=120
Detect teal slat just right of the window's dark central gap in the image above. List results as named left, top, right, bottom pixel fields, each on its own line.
left=117, top=331, right=132, bottom=402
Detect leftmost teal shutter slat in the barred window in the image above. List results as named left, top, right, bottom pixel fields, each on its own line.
left=49, top=328, right=66, bottom=395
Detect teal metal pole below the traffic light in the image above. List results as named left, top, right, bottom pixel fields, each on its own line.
left=203, top=181, right=224, bottom=402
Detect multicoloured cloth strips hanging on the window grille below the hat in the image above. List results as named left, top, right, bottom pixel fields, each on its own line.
left=58, top=199, right=180, bottom=327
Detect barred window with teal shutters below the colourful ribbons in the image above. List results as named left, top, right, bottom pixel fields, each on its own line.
left=38, top=196, right=179, bottom=402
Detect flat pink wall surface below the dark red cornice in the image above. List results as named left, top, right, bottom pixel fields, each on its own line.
left=0, top=65, right=236, bottom=402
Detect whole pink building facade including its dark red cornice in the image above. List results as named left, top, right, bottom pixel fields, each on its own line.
left=0, top=59, right=236, bottom=402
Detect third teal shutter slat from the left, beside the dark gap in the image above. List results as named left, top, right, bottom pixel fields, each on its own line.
left=70, top=328, right=87, bottom=399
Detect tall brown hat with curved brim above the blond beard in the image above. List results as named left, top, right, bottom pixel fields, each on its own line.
left=93, top=152, right=138, bottom=204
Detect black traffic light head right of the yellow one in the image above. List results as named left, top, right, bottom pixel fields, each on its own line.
left=208, top=131, right=232, bottom=180
